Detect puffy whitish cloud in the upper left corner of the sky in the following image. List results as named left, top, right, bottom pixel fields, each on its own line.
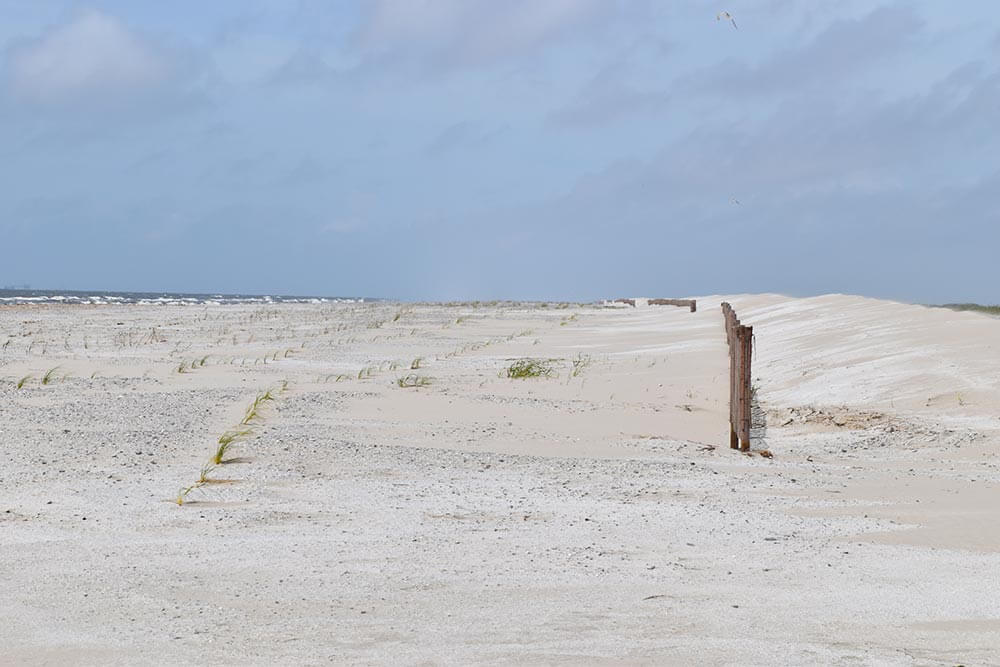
left=7, top=11, right=170, bottom=103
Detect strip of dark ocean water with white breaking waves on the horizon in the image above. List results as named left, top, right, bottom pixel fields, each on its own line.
left=0, top=289, right=368, bottom=305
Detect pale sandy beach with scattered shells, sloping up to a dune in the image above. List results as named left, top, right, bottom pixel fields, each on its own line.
left=0, top=295, right=1000, bottom=665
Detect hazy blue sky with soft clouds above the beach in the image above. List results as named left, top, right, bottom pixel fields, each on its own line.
left=0, top=0, right=1000, bottom=303
